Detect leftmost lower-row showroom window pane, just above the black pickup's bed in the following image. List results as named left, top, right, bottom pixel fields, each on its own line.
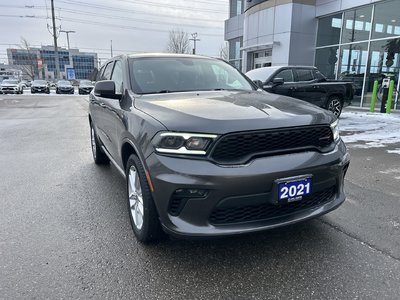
left=315, top=46, right=339, bottom=79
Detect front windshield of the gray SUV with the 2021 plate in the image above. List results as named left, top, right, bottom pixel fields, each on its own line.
left=129, top=57, right=254, bottom=94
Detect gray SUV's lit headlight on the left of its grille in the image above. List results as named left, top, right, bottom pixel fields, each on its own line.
left=153, top=132, right=218, bottom=155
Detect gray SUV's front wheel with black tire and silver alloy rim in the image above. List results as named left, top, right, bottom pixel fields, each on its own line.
left=126, top=154, right=165, bottom=244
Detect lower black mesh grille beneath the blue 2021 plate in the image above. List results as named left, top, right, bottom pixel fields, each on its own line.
left=210, top=186, right=336, bottom=225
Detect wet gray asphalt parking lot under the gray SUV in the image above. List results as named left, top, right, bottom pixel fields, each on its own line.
left=0, top=94, right=400, bottom=299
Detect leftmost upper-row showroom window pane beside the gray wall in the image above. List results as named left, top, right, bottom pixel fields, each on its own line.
left=317, top=14, right=342, bottom=47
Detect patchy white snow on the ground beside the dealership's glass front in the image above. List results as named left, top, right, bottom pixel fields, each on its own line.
left=339, top=112, right=400, bottom=150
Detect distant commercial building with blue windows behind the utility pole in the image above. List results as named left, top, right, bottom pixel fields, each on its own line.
left=7, top=46, right=97, bottom=80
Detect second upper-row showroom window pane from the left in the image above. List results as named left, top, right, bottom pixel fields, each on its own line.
left=342, top=6, right=372, bottom=43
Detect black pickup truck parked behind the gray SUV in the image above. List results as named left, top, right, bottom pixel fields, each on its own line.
left=246, top=66, right=354, bottom=117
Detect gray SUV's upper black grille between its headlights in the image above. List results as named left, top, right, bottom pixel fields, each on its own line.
left=210, top=126, right=333, bottom=164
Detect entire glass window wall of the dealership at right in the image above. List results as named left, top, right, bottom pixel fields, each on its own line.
left=315, top=0, right=400, bottom=109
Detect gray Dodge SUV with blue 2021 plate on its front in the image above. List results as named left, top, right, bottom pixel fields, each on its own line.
left=89, top=54, right=350, bottom=242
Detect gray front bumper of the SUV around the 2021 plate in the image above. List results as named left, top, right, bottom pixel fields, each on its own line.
left=146, top=141, right=350, bottom=237
